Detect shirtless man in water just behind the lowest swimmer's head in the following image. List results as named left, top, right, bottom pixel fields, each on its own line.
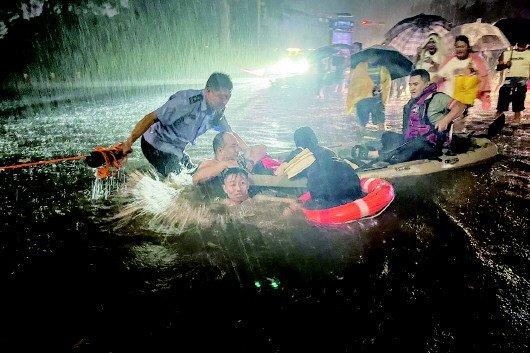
left=192, top=131, right=280, bottom=196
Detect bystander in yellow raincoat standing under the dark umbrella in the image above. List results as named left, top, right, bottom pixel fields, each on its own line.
left=346, top=62, right=391, bottom=130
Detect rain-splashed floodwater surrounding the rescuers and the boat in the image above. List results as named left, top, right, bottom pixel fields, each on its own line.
left=0, top=80, right=530, bottom=352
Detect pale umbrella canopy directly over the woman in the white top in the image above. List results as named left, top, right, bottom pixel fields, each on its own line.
left=443, top=21, right=510, bottom=51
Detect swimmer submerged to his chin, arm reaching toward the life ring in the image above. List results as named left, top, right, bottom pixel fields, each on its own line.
left=220, top=167, right=301, bottom=216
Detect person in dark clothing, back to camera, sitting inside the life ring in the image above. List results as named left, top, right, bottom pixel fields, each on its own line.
left=276, top=126, right=364, bottom=209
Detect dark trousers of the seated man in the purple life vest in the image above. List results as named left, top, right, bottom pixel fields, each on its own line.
left=381, top=131, right=442, bottom=164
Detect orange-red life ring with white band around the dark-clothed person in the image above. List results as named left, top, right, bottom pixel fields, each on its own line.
left=300, top=178, right=394, bottom=225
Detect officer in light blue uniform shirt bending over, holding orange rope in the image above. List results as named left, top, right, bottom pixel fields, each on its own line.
left=122, top=72, right=248, bottom=176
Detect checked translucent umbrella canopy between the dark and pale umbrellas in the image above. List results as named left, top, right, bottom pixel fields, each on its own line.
left=384, top=14, right=451, bottom=56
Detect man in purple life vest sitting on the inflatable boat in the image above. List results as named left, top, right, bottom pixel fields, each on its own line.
left=360, top=69, right=467, bottom=164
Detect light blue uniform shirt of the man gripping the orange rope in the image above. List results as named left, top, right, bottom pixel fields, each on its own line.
left=143, top=89, right=231, bottom=158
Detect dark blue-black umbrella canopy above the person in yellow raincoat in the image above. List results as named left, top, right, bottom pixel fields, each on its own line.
left=351, top=45, right=413, bottom=80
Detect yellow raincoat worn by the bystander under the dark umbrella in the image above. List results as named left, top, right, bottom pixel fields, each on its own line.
left=346, top=62, right=392, bottom=114
